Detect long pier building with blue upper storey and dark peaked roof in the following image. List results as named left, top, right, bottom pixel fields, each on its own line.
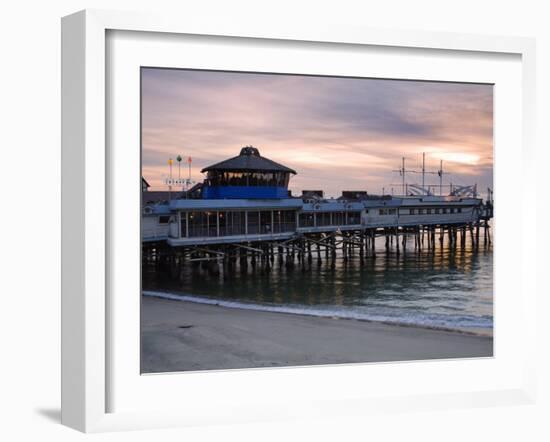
left=142, top=146, right=492, bottom=266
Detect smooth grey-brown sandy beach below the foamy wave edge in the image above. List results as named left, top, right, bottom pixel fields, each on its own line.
left=141, top=296, right=493, bottom=373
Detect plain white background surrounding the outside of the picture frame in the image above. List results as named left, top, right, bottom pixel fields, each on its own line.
left=0, top=0, right=550, bottom=441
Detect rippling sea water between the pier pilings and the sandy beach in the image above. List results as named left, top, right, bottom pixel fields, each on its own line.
left=143, top=238, right=493, bottom=335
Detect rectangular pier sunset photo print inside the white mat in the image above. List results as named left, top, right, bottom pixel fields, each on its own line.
left=140, top=67, right=494, bottom=373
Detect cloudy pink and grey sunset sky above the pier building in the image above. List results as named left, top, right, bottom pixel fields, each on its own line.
left=142, top=68, right=493, bottom=197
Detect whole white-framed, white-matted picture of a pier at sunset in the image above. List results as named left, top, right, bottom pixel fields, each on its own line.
left=62, top=11, right=536, bottom=431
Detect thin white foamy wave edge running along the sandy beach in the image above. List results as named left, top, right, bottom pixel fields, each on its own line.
left=142, top=290, right=493, bottom=338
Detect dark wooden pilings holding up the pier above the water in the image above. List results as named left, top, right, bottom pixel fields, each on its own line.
left=143, top=220, right=491, bottom=275
